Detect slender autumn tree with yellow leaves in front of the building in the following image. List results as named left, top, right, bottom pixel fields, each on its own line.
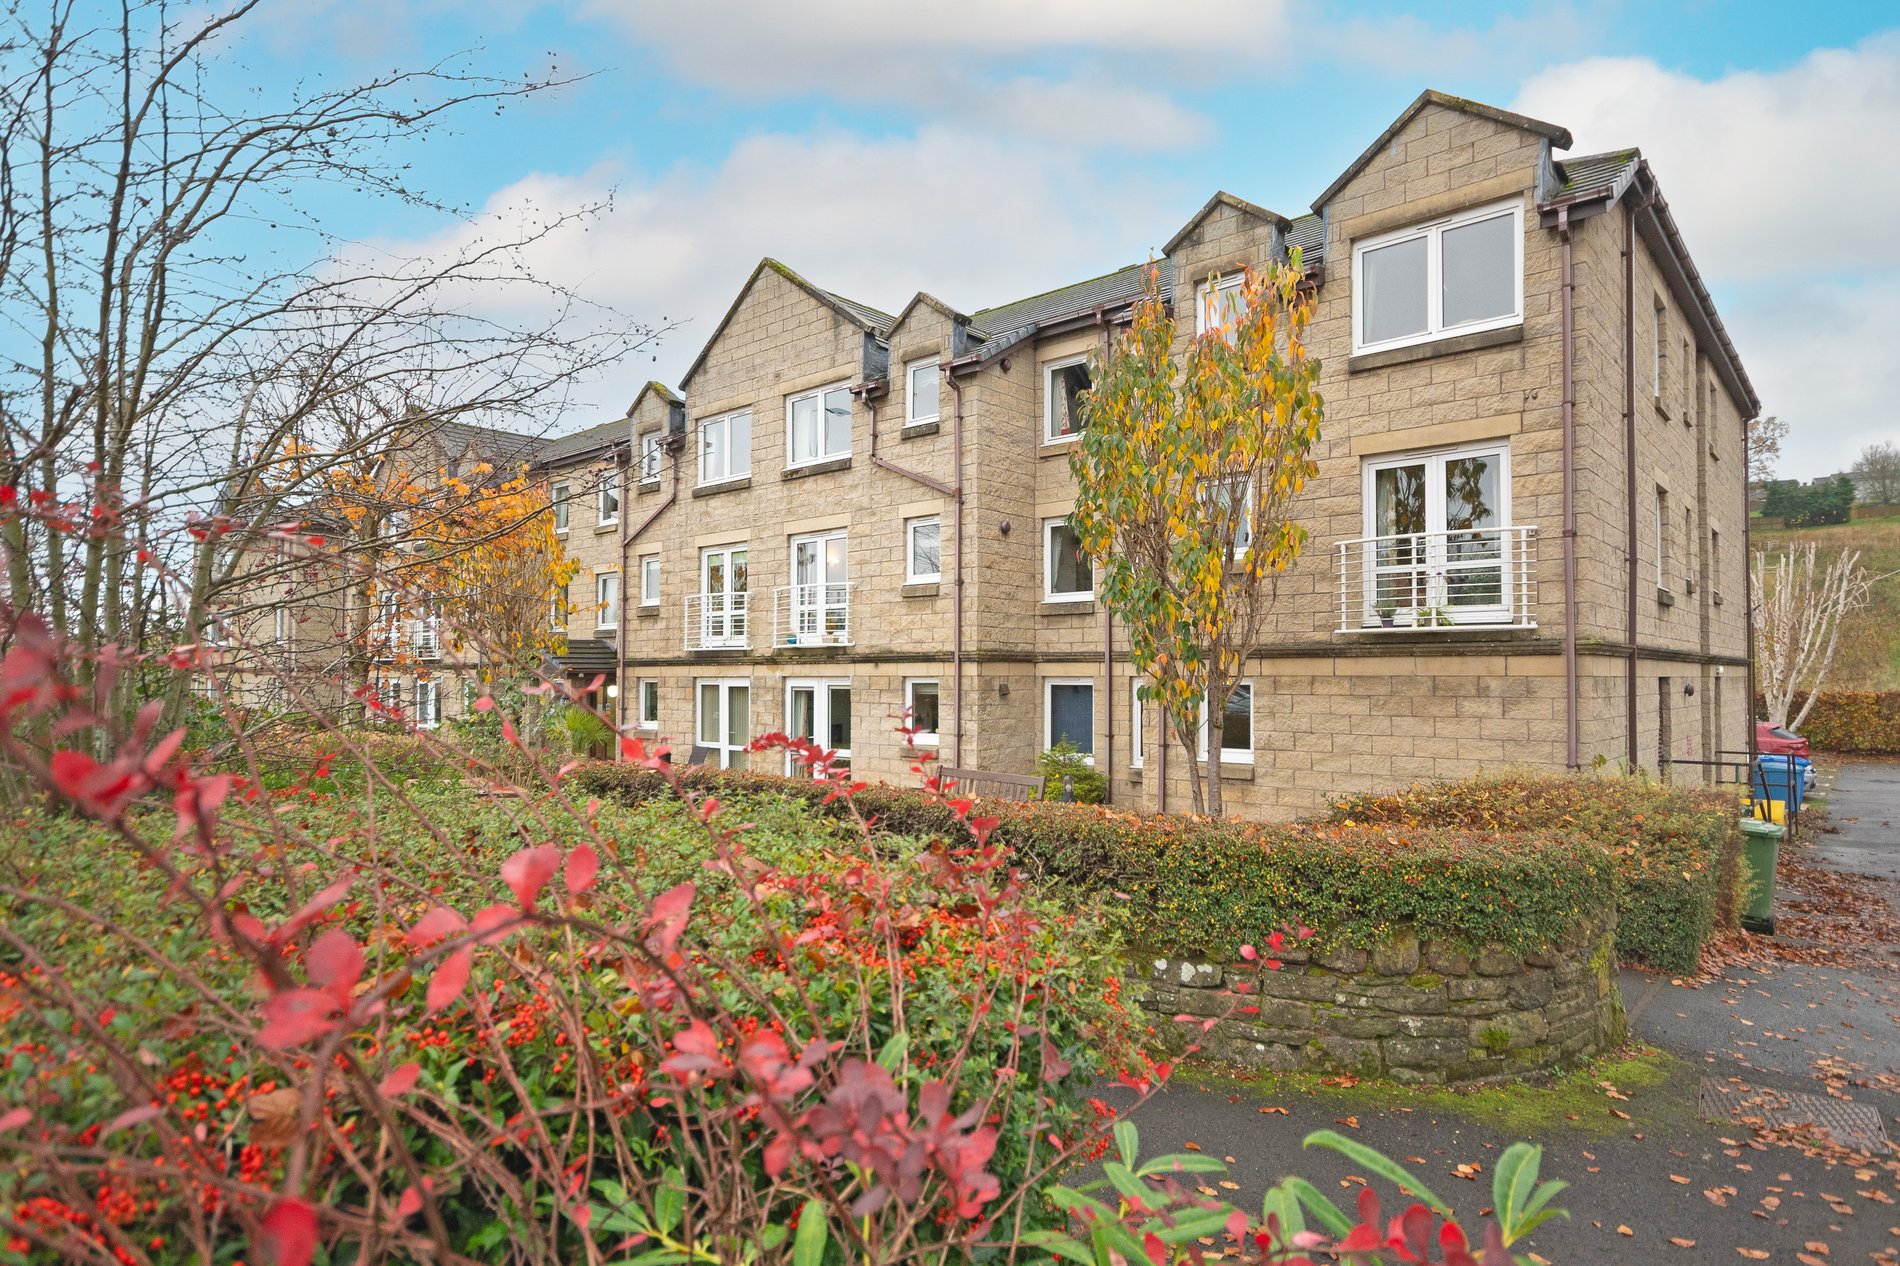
left=1070, top=251, right=1324, bottom=814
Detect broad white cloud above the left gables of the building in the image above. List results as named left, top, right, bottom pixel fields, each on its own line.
left=370, top=129, right=1199, bottom=424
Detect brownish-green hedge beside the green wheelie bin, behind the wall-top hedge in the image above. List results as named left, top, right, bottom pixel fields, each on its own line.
left=1334, top=776, right=1739, bottom=971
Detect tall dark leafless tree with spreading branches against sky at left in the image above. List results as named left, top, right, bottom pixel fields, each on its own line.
left=0, top=0, right=656, bottom=718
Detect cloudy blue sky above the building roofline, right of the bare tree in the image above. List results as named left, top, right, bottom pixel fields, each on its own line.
left=232, top=0, right=1900, bottom=477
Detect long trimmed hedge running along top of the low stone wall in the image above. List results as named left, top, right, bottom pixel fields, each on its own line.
left=570, top=764, right=1615, bottom=956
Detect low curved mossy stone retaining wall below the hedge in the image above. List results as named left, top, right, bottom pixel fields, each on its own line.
left=1134, top=918, right=1625, bottom=1084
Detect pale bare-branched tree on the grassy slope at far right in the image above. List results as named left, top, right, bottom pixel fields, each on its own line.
left=1754, top=544, right=1877, bottom=730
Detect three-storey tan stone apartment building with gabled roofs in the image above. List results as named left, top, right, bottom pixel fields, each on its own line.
left=608, top=93, right=1759, bottom=817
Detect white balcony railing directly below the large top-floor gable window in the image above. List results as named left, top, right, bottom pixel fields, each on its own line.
left=1338, top=527, right=1537, bottom=633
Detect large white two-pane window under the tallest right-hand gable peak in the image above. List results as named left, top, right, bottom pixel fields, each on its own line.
left=1353, top=198, right=1524, bottom=352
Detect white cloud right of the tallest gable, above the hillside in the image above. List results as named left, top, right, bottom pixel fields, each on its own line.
left=1512, top=34, right=1900, bottom=479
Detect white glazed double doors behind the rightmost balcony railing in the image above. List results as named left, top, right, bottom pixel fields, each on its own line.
left=1366, top=445, right=1511, bottom=623
